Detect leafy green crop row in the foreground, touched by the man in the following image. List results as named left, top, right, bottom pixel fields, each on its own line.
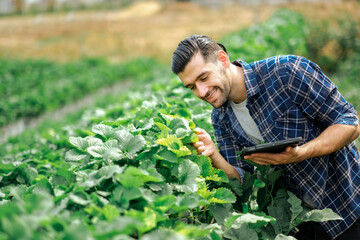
left=0, top=72, right=344, bottom=239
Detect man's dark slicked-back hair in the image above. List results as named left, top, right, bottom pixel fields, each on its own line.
left=171, top=35, right=226, bottom=74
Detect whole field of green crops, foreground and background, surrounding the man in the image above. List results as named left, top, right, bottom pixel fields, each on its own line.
left=0, top=4, right=360, bottom=240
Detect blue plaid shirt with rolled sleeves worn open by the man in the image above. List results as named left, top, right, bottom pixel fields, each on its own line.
left=212, top=55, right=360, bottom=238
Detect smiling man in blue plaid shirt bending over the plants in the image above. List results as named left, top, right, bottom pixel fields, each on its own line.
left=172, top=35, right=360, bottom=239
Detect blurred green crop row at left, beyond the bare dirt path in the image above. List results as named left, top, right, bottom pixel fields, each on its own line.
left=0, top=56, right=166, bottom=127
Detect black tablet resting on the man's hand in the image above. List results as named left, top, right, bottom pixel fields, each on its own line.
left=241, top=137, right=303, bottom=158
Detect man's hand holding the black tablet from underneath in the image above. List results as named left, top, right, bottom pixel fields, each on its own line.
left=244, top=146, right=304, bottom=165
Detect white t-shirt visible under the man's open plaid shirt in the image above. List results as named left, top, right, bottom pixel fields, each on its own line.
left=230, top=100, right=264, bottom=144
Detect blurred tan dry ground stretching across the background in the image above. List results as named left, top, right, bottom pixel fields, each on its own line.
left=0, top=1, right=360, bottom=63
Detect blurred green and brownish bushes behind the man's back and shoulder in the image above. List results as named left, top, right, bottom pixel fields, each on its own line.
left=219, top=9, right=360, bottom=73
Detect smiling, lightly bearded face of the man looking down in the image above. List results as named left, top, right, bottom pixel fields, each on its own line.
left=178, top=53, right=230, bottom=108
